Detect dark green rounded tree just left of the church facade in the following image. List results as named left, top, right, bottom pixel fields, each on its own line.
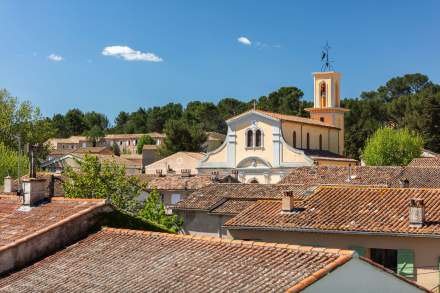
left=159, top=119, right=207, bottom=157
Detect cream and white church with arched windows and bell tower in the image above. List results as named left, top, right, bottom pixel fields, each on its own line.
left=198, top=72, right=357, bottom=183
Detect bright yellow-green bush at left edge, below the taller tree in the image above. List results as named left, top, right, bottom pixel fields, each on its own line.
left=0, top=143, right=29, bottom=180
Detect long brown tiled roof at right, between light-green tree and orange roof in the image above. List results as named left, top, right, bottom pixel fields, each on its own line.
left=280, top=166, right=440, bottom=188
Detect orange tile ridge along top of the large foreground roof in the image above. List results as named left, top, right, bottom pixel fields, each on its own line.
left=101, top=227, right=354, bottom=259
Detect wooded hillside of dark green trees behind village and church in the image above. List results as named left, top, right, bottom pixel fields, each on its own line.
left=0, top=73, right=440, bottom=169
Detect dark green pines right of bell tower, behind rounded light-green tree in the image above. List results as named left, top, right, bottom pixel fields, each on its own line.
left=342, top=73, right=440, bottom=158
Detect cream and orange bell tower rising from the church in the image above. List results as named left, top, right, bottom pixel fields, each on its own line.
left=305, top=71, right=349, bottom=155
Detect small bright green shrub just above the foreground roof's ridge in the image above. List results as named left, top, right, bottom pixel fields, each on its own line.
left=138, top=189, right=183, bottom=231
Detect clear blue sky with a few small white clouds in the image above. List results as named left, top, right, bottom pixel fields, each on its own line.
left=0, top=0, right=440, bottom=120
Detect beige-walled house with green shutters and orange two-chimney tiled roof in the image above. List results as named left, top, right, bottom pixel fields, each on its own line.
left=224, top=186, right=440, bottom=292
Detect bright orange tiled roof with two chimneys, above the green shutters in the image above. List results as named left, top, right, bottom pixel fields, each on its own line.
left=225, top=187, right=440, bottom=237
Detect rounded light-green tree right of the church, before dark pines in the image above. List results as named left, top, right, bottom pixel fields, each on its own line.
left=362, top=127, right=423, bottom=166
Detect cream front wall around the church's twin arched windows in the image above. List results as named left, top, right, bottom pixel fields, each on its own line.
left=236, top=121, right=273, bottom=164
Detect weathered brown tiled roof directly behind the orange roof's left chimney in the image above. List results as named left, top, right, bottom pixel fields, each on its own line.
left=175, top=183, right=308, bottom=212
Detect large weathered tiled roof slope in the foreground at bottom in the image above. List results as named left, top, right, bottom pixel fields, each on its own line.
left=0, top=229, right=353, bottom=292
